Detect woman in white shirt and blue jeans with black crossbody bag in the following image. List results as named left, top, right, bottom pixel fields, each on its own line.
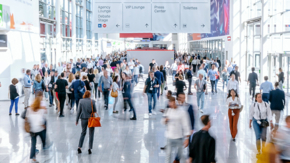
left=249, top=93, right=273, bottom=154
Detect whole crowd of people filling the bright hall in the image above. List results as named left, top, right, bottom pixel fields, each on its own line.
left=9, top=52, right=290, bottom=163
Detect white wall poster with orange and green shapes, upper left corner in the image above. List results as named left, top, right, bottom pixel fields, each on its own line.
left=0, top=0, right=39, bottom=33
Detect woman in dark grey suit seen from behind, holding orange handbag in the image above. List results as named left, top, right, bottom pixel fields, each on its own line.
left=76, top=91, right=97, bottom=154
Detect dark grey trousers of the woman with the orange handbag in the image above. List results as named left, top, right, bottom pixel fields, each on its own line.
left=79, top=119, right=95, bottom=149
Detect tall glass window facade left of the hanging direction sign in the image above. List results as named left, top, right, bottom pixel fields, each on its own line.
left=39, top=0, right=98, bottom=65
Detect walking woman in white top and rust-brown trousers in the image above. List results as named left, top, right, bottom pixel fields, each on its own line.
left=227, top=89, right=241, bottom=141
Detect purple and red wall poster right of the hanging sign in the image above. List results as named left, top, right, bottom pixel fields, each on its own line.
left=188, top=0, right=230, bottom=41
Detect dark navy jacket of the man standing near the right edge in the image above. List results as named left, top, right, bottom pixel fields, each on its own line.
left=269, top=88, right=285, bottom=110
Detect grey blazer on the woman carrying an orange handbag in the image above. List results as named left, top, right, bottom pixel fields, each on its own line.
left=76, top=98, right=97, bottom=122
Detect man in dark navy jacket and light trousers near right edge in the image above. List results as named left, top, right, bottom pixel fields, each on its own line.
left=269, top=82, right=285, bottom=127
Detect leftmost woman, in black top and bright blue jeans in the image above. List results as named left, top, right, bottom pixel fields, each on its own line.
left=8, top=78, right=19, bottom=116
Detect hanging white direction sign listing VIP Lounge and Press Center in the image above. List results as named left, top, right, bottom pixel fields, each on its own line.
left=94, top=0, right=211, bottom=33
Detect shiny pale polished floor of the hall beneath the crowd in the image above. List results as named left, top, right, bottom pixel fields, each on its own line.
left=0, top=75, right=288, bottom=163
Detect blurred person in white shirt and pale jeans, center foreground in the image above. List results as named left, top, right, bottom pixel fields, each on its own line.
left=162, top=97, right=191, bottom=163
